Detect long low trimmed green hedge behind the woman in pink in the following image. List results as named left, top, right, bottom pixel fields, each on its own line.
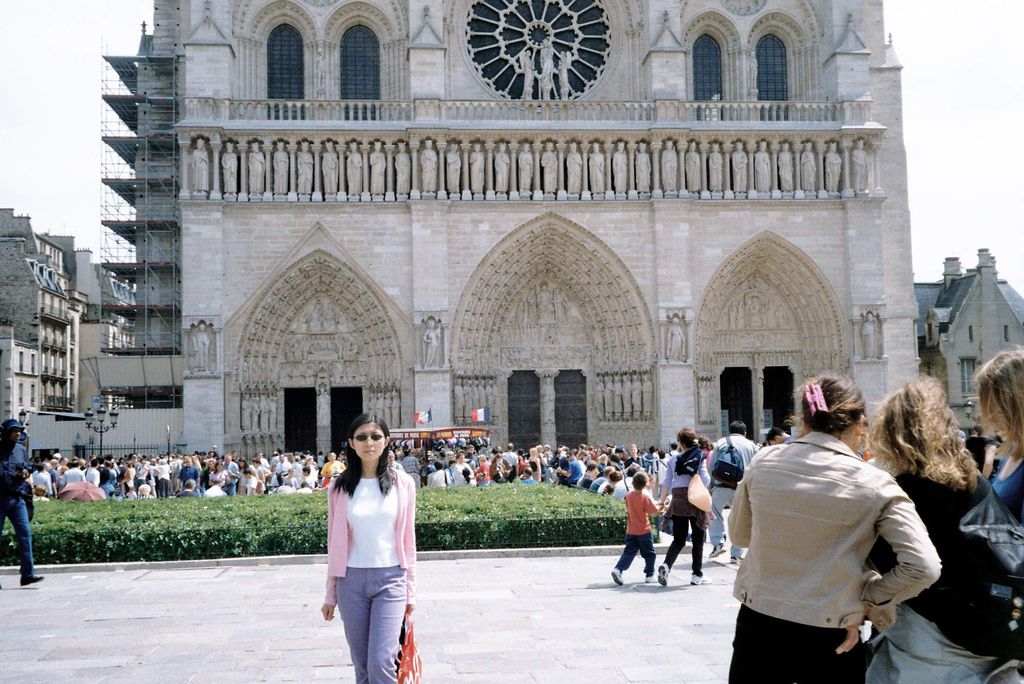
left=0, top=484, right=651, bottom=565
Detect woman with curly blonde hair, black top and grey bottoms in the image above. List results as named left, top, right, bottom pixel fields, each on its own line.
left=867, top=378, right=1006, bottom=684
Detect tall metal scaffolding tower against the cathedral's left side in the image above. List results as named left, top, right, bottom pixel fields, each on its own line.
left=100, top=25, right=182, bottom=408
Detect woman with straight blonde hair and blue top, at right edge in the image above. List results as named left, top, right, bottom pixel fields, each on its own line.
left=977, top=350, right=1024, bottom=520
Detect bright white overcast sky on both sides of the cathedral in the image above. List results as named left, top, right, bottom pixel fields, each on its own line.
left=0, top=0, right=1024, bottom=293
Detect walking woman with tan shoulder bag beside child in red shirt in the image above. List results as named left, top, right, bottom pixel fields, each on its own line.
left=657, top=427, right=711, bottom=587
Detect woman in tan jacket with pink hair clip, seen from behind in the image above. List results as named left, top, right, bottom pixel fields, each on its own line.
left=728, top=375, right=940, bottom=684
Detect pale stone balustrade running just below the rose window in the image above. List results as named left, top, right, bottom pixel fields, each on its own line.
left=180, top=97, right=870, bottom=129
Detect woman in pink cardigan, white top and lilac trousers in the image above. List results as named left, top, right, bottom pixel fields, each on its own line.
left=321, top=414, right=416, bottom=684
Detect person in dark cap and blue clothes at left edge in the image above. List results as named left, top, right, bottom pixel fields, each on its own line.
left=0, top=418, right=42, bottom=587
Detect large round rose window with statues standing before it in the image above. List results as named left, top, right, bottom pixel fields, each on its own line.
left=466, top=0, right=610, bottom=99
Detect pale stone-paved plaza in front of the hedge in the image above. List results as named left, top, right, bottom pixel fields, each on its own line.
left=0, top=544, right=738, bottom=684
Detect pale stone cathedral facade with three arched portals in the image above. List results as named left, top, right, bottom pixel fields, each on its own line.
left=161, top=0, right=918, bottom=454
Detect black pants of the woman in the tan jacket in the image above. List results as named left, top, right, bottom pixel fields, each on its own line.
left=729, top=605, right=865, bottom=684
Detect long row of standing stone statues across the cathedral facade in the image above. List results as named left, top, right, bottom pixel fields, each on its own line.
left=181, top=138, right=879, bottom=202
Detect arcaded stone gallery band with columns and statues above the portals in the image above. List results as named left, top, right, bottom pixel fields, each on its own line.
left=178, top=126, right=885, bottom=202
